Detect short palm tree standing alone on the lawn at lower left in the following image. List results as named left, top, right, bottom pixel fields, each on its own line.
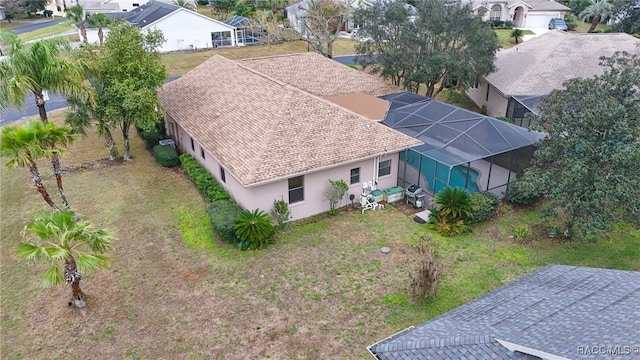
left=16, top=211, right=113, bottom=308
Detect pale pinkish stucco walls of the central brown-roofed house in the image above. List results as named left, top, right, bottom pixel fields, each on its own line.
left=165, top=116, right=398, bottom=220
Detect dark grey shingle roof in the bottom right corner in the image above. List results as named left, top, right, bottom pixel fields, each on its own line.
left=368, top=265, right=640, bottom=360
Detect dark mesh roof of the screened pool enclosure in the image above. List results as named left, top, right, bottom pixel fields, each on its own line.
left=381, top=92, right=544, bottom=167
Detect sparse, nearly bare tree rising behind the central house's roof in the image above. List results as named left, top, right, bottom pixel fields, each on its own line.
left=298, top=0, right=352, bottom=58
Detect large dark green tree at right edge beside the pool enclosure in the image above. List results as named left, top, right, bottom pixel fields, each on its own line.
left=532, top=53, right=640, bottom=236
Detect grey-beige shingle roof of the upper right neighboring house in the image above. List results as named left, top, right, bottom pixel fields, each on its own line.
left=485, top=31, right=640, bottom=96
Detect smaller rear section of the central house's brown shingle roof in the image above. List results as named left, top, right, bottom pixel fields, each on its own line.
left=239, top=53, right=402, bottom=96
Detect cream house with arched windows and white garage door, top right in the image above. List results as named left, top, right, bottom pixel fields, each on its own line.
left=470, top=0, right=571, bottom=29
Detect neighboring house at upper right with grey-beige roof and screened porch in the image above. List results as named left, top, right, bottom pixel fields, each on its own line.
left=467, top=31, right=640, bottom=127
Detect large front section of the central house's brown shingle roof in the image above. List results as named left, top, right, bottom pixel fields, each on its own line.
left=159, top=55, right=421, bottom=186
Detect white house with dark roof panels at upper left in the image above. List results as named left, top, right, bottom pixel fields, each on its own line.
left=82, top=0, right=238, bottom=52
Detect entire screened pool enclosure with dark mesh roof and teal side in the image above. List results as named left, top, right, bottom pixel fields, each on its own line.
left=381, top=92, right=544, bottom=197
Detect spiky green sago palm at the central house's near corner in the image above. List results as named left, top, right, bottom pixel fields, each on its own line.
left=233, top=209, right=274, bottom=250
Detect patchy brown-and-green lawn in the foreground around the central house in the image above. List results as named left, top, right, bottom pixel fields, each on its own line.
left=0, top=111, right=640, bottom=359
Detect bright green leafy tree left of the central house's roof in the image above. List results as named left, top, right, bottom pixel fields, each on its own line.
left=96, top=22, right=167, bottom=161
